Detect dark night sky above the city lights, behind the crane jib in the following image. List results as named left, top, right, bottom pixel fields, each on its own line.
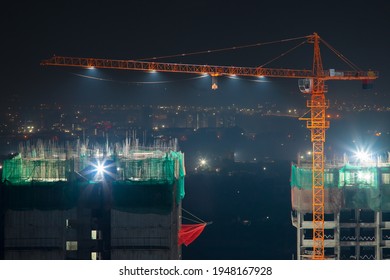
left=0, top=0, right=390, bottom=105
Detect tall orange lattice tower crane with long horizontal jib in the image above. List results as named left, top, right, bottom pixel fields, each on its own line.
left=41, top=33, right=378, bottom=259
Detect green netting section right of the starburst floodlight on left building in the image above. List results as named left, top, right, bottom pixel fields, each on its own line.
left=112, top=152, right=185, bottom=213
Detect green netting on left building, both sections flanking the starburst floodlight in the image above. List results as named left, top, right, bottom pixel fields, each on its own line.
left=0, top=151, right=185, bottom=213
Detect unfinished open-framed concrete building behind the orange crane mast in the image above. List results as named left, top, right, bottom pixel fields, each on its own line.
left=291, top=154, right=390, bottom=260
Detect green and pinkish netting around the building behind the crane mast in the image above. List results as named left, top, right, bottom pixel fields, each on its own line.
left=291, top=165, right=390, bottom=213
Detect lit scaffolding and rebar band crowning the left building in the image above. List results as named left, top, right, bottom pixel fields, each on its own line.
left=2, top=140, right=185, bottom=187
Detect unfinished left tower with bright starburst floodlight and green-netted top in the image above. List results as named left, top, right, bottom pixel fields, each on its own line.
left=0, top=141, right=185, bottom=259
